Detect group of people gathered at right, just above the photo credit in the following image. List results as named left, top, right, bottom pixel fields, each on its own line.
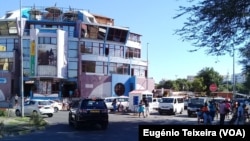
left=197, top=100, right=248, bottom=125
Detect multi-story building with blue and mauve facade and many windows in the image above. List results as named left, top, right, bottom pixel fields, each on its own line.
left=0, top=6, right=154, bottom=100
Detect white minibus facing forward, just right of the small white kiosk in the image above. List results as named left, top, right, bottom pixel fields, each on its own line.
left=158, top=96, right=184, bottom=115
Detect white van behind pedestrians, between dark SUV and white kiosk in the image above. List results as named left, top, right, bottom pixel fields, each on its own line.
left=104, top=96, right=129, bottom=111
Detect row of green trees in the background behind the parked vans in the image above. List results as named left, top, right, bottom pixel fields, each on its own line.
left=156, top=68, right=249, bottom=95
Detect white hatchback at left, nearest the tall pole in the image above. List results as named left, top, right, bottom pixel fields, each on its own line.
left=16, top=99, right=54, bottom=117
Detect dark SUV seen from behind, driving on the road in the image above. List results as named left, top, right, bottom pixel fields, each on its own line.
left=68, top=98, right=109, bottom=130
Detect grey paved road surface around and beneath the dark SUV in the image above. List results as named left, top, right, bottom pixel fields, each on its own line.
left=1, top=111, right=229, bottom=141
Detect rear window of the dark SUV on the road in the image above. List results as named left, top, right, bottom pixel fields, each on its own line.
left=81, top=100, right=106, bottom=109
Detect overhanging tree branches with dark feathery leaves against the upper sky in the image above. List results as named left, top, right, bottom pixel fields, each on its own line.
left=174, top=0, right=250, bottom=56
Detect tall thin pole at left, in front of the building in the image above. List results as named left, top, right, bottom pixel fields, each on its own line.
left=19, top=0, right=24, bottom=117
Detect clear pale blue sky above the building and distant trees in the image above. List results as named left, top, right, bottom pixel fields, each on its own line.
left=0, top=0, right=242, bottom=83
